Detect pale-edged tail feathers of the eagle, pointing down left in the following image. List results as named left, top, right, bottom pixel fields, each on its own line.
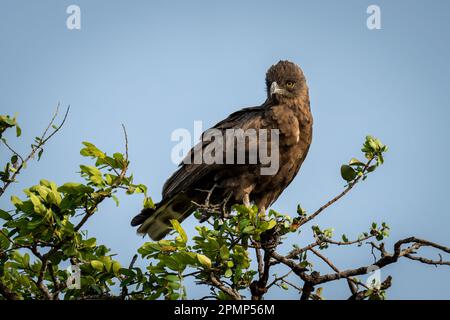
left=131, top=195, right=194, bottom=241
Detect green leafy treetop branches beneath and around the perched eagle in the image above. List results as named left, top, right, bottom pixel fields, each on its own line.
left=0, top=113, right=448, bottom=300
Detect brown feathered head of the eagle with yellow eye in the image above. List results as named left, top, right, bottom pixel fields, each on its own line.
left=266, top=60, right=307, bottom=102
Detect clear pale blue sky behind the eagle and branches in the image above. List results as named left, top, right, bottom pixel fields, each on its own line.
left=0, top=0, right=450, bottom=299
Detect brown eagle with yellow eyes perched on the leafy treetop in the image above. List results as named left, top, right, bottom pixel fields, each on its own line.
left=131, top=60, right=313, bottom=241
